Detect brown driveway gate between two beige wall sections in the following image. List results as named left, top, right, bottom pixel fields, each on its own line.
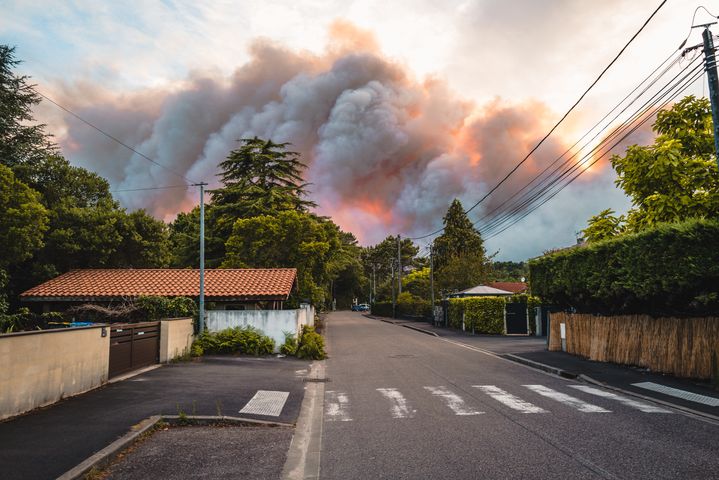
left=109, top=322, right=160, bottom=378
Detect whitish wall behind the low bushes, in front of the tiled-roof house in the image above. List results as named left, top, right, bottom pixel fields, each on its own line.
left=207, top=305, right=315, bottom=352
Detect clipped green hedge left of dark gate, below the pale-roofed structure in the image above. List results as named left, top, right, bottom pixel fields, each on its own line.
left=447, top=297, right=507, bottom=334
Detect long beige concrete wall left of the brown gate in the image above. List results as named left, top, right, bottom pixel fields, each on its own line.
left=0, top=326, right=110, bottom=419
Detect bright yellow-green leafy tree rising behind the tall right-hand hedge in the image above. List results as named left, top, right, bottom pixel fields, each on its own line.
left=585, top=96, right=719, bottom=241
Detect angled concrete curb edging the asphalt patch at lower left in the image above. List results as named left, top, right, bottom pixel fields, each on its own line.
left=57, top=415, right=294, bottom=480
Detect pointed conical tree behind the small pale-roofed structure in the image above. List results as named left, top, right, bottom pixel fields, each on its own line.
left=434, top=199, right=490, bottom=291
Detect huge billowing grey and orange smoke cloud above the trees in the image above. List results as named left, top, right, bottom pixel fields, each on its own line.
left=52, top=23, right=624, bottom=248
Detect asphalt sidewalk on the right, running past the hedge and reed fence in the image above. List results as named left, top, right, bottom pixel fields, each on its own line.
left=370, top=317, right=719, bottom=420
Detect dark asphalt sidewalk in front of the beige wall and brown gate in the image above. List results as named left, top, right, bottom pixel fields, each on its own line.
left=0, top=357, right=309, bottom=480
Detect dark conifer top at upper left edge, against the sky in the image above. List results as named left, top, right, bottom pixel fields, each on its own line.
left=0, top=45, right=55, bottom=167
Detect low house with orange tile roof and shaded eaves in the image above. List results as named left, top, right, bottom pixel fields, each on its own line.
left=20, top=268, right=297, bottom=312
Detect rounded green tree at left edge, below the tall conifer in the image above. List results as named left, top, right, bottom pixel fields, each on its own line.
left=0, top=165, right=48, bottom=268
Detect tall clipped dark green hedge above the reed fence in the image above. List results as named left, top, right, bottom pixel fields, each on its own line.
left=529, top=220, right=719, bottom=315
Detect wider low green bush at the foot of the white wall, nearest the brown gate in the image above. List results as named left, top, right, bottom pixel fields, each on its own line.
left=191, top=327, right=275, bottom=356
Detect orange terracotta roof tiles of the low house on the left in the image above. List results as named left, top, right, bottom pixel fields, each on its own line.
left=20, top=268, right=297, bottom=300
